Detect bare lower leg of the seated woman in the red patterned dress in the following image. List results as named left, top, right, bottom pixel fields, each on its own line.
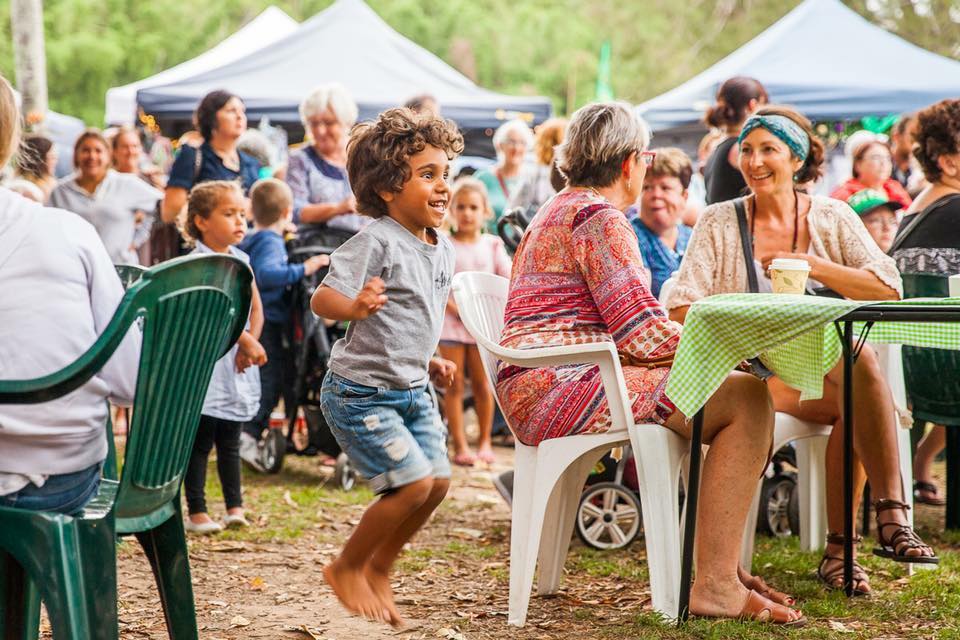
left=667, top=372, right=800, bottom=620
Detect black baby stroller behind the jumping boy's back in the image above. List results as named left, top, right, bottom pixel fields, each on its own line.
left=251, top=225, right=356, bottom=490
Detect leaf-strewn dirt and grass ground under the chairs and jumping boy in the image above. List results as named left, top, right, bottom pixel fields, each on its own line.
left=37, top=440, right=960, bottom=640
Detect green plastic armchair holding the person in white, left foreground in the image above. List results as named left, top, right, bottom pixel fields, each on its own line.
left=0, top=255, right=253, bottom=640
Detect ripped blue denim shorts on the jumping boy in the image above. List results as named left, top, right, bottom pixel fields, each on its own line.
left=320, top=371, right=450, bottom=494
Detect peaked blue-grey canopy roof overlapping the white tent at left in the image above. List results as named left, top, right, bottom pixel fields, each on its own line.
left=137, top=0, right=552, bottom=128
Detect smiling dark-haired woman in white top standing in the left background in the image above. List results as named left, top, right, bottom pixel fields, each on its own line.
left=50, top=129, right=163, bottom=264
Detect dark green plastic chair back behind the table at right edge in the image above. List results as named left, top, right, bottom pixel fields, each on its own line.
left=903, top=273, right=960, bottom=425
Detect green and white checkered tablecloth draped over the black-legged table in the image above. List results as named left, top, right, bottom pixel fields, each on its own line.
left=666, top=293, right=960, bottom=416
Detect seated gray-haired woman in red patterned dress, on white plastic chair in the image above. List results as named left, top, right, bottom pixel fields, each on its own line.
left=496, top=102, right=804, bottom=625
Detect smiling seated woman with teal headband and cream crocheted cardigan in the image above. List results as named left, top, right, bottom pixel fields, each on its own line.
left=665, top=106, right=937, bottom=594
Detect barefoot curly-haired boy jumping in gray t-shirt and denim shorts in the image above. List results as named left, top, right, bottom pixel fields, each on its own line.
left=311, top=109, right=463, bottom=626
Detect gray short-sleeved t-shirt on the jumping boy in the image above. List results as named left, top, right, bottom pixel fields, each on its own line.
left=323, top=216, right=454, bottom=389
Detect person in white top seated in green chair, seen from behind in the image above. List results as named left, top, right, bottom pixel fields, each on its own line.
left=0, top=76, right=140, bottom=514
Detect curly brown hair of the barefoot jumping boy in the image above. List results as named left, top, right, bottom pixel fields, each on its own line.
left=347, top=108, right=463, bottom=218
